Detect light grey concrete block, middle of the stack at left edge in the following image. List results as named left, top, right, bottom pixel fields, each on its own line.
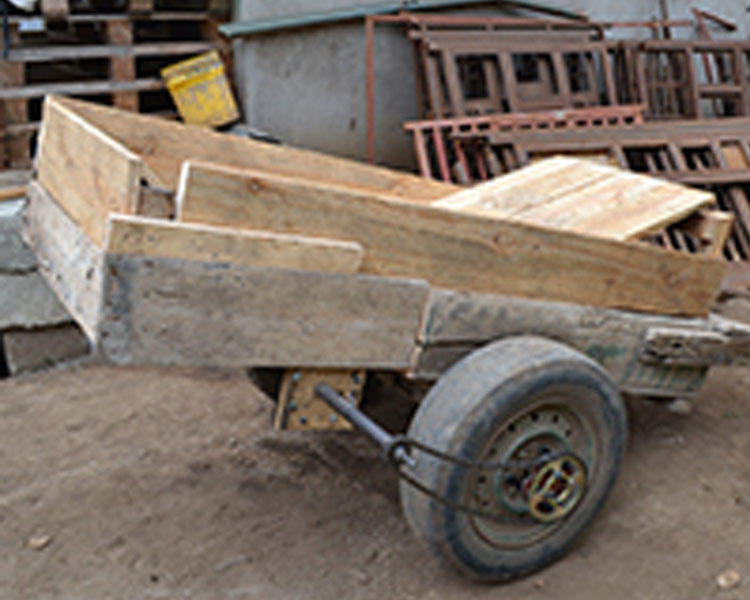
left=0, top=271, right=71, bottom=329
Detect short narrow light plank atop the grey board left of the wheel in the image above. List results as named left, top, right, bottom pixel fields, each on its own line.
left=106, top=215, right=364, bottom=273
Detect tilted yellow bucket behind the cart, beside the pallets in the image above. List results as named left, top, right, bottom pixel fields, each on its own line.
left=161, top=50, right=240, bottom=127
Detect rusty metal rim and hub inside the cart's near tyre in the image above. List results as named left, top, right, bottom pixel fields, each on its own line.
left=467, top=393, right=601, bottom=549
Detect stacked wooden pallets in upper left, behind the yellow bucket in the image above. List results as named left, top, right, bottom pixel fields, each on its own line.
left=0, top=2, right=227, bottom=168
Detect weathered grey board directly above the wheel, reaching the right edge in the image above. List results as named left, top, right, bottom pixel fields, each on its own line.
left=411, top=289, right=750, bottom=396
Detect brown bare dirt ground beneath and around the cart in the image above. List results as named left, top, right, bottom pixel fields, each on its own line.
left=0, top=316, right=750, bottom=600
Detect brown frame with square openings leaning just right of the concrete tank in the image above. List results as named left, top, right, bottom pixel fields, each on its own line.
left=410, top=30, right=617, bottom=118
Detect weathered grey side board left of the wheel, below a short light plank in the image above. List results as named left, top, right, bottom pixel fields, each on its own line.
left=101, top=254, right=428, bottom=369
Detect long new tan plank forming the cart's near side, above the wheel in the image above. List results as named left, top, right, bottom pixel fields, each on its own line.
left=177, top=163, right=725, bottom=315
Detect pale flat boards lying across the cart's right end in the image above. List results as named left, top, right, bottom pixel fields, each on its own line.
left=434, top=157, right=716, bottom=240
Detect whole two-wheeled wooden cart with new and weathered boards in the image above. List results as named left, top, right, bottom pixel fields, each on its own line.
left=26, top=98, right=750, bottom=581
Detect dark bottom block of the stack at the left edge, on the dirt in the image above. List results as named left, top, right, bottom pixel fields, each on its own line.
left=3, top=323, right=90, bottom=375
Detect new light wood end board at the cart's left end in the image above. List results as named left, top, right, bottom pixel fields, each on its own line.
left=37, top=99, right=143, bottom=247
